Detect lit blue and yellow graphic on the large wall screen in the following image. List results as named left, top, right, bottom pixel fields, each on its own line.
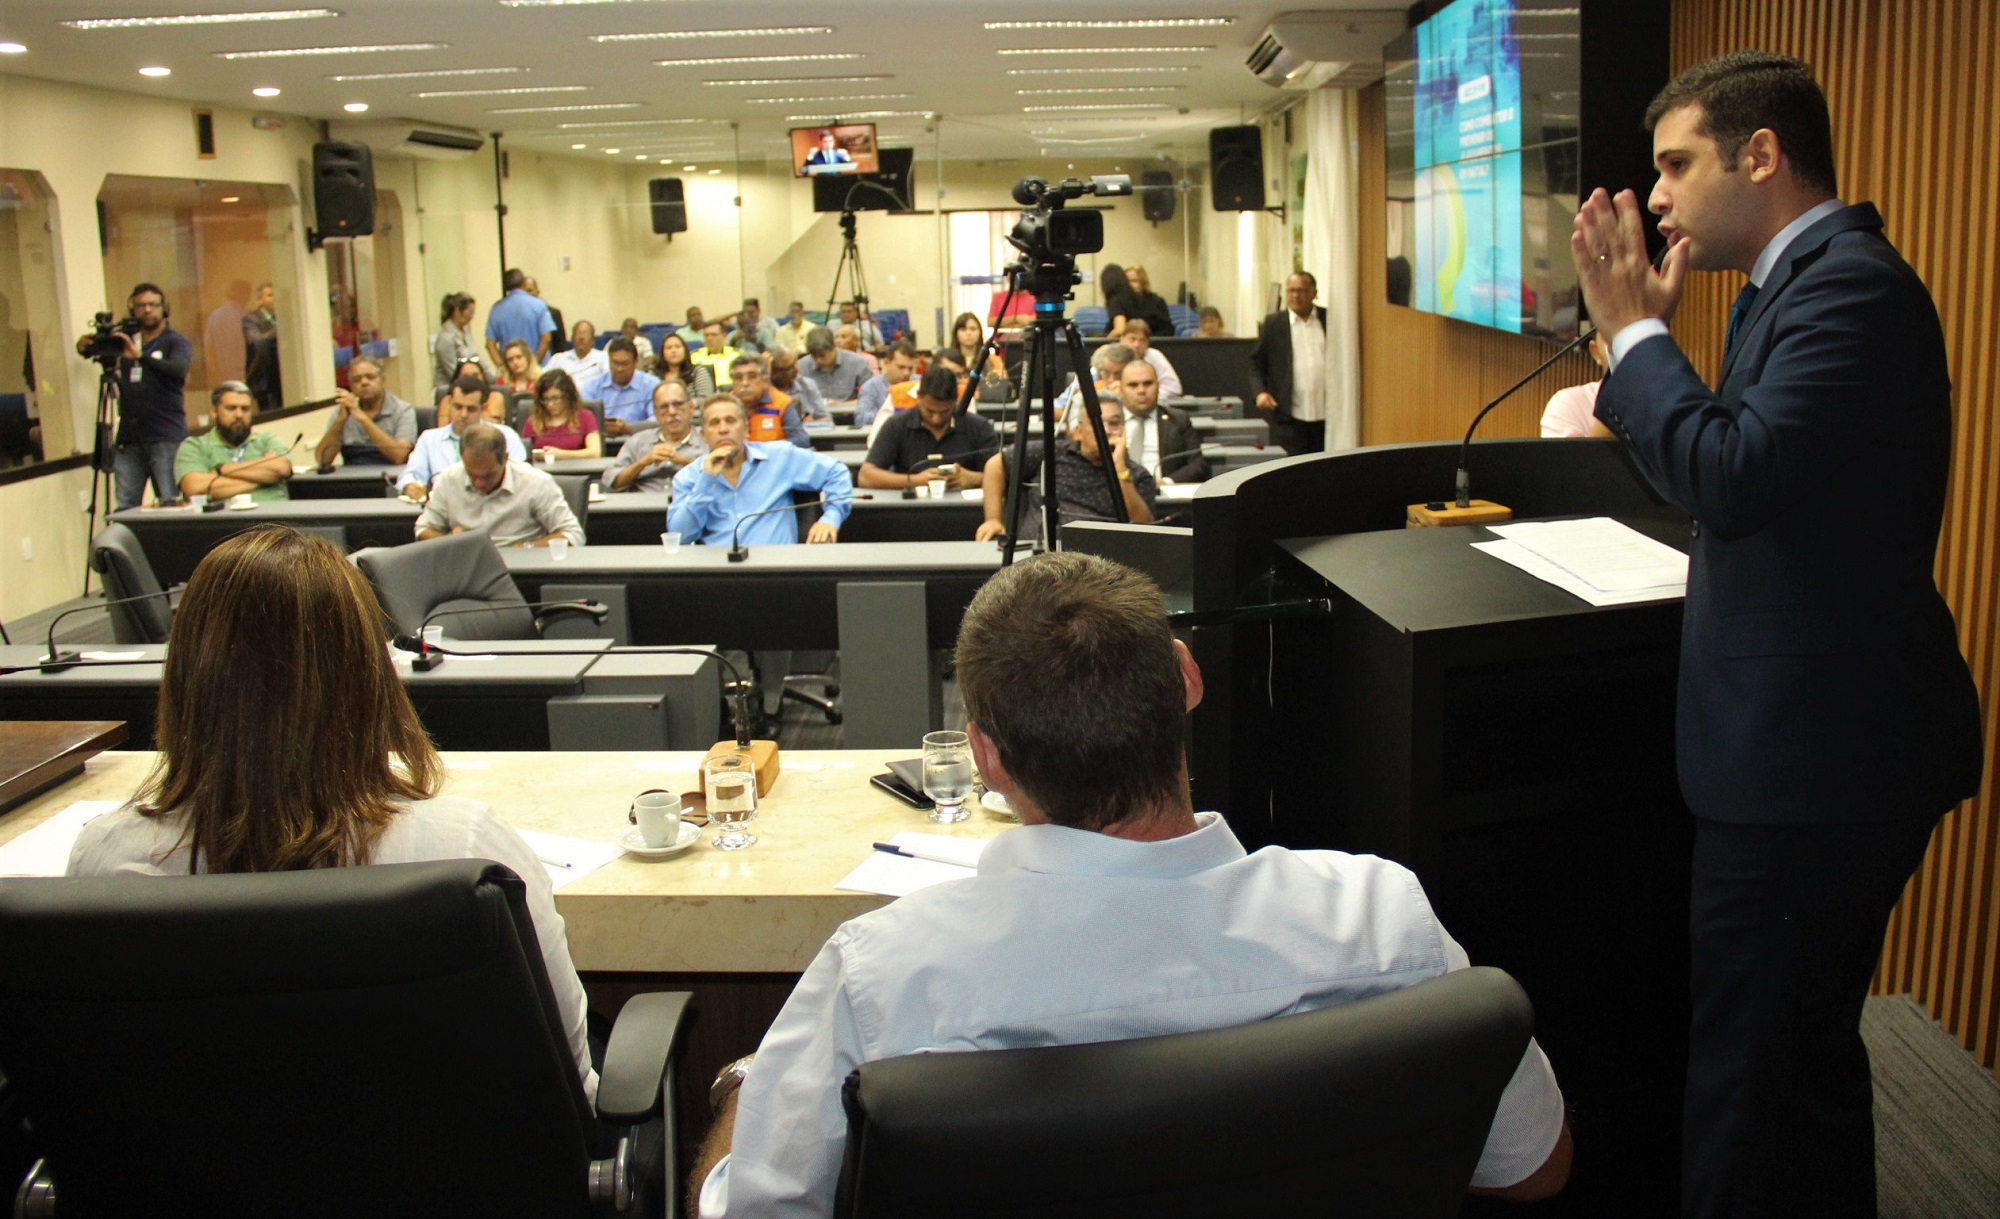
left=1412, top=0, right=1522, bottom=334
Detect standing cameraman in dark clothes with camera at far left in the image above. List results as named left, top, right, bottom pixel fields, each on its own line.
left=76, top=284, right=194, bottom=510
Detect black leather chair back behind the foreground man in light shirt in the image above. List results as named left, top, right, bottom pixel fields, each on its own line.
left=834, top=969, right=1534, bottom=1219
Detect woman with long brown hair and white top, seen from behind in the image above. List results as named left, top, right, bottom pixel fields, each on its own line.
left=68, top=526, right=596, bottom=1095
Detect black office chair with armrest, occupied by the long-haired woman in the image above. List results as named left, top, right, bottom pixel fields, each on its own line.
left=0, top=859, right=688, bottom=1219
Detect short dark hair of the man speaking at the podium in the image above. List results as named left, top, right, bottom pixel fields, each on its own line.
left=1646, top=50, right=1840, bottom=194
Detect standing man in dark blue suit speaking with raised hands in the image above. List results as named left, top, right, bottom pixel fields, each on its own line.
left=1570, top=52, right=1982, bottom=1215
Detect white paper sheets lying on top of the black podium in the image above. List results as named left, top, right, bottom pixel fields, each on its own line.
left=1472, top=516, right=1688, bottom=606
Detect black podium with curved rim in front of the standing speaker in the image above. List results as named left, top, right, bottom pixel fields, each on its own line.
left=1192, top=440, right=1692, bottom=1215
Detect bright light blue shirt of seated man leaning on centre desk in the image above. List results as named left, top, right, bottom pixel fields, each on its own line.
left=666, top=444, right=854, bottom=546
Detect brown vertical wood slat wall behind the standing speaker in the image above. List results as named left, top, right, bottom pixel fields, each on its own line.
left=1360, top=0, right=2000, bottom=1073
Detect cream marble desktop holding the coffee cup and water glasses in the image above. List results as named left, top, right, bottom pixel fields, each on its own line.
left=0, top=749, right=1010, bottom=973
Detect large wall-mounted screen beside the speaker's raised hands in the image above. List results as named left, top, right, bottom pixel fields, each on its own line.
left=1384, top=0, right=1576, bottom=338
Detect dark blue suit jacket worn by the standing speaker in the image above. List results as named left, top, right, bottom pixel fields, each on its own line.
left=1596, top=204, right=1982, bottom=823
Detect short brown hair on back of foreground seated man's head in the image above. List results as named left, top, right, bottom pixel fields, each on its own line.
left=958, top=552, right=1188, bottom=829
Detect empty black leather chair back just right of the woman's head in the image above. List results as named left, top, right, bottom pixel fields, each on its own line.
left=354, top=534, right=534, bottom=639
